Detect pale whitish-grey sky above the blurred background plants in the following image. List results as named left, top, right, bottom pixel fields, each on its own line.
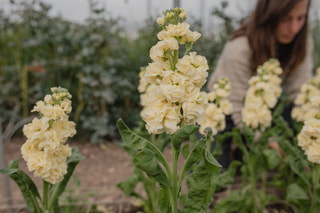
left=0, top=0, right=320, bottom=32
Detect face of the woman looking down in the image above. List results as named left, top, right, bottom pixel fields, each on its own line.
left=275, top=0, right=309, bottom=44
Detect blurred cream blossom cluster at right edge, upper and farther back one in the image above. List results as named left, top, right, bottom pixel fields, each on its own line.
left=291, top=68, right=320, bottom=122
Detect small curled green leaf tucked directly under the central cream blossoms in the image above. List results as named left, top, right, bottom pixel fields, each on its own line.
left=171, top=125, right=199, bottom=151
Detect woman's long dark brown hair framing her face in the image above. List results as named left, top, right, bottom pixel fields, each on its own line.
left=231, top=0, right=311, bottom=72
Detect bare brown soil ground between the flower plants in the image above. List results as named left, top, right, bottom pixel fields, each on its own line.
left=0, top=138, right=294, bottom=213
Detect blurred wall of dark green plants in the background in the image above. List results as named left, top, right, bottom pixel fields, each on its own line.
left=0, top=0, right=320, bottom=143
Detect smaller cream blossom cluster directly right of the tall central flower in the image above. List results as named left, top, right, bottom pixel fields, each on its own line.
left=198, top=78, right=233, bottom=136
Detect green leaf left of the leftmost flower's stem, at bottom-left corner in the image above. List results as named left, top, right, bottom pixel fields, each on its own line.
left=0, top=159, right=41, bottom=212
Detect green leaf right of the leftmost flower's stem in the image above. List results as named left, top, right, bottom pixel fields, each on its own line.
left=49, top=147, right=84, bottom=211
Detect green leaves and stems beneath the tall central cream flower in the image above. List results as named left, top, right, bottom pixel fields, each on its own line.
left=118, top=120, right=221, bottom=213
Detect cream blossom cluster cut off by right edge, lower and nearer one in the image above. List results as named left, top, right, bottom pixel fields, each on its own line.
left=298, top=96, right=320, bottom=163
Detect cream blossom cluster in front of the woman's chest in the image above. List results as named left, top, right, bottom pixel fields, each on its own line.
left=242, top=59, right=282, bottom=129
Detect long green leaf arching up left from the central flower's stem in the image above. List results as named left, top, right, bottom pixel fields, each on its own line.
left=117, top=119, right=171, bottom=174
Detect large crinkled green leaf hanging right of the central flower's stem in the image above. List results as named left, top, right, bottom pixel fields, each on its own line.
left=182, top=149, right=221, bottom=213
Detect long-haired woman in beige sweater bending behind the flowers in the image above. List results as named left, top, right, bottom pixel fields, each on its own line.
left=207, top=0, right=313, bottom=167
